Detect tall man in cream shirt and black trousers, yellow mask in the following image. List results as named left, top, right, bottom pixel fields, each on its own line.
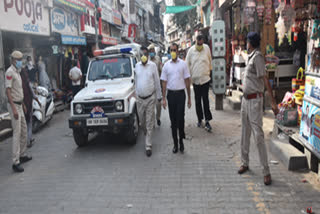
left=186, top=35, right=212, bottom=132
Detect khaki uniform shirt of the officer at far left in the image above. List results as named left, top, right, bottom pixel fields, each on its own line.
left=5, top=65, right=23, bottom=102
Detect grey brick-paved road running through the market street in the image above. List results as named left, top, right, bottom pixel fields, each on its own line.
left=0, top=94, right=320, bottom=214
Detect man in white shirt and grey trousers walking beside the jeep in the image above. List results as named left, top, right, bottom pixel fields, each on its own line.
left=136, top=47, right=161, bottom=157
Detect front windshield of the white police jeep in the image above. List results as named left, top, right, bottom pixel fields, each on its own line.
left=88, top=57, right=132, bottom=81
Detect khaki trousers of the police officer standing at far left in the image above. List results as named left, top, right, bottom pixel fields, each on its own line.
left=8, top=104, right=27, bottom=164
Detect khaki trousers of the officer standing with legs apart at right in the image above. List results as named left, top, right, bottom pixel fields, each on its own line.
left=241, top=97, right=270, bottom=176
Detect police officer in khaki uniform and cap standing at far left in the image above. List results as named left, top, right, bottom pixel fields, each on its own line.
left=5, top=51, right=32, bottom=172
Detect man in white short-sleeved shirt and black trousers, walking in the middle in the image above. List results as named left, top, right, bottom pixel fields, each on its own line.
left=161, top=43, right=191, bottom=153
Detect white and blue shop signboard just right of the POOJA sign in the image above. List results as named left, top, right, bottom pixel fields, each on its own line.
left=51, top=7, right=79, bottom=36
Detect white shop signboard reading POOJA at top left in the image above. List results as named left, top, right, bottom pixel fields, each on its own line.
left=0, top=0, right=50, bottom=36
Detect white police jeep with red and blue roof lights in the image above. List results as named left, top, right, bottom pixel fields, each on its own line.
left=69, top=44, right=140, bottom=147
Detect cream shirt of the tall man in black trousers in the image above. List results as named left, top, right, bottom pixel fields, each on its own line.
left=186, top=44, right=212, bottom=85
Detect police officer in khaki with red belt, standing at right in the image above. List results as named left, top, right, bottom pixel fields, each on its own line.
left=238, top=32, right=278, bottom=185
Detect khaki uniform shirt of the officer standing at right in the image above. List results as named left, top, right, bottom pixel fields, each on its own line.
left=243, top=50, right=266, bottom=95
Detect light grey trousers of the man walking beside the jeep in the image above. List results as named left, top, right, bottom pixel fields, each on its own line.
left=137, top=94, right=156, bottom=149
